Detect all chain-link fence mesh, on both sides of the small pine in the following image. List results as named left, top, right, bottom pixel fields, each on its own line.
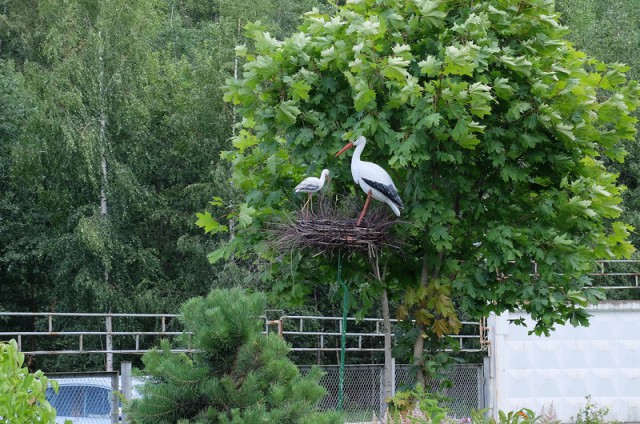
left=46, top=364, right=484, bottom=424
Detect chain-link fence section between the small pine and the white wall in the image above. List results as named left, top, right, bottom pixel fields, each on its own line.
left=300, top=364, right=484, bottom=422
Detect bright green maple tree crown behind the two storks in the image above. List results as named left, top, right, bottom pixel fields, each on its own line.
left=218, top=0, right=640, bottom=354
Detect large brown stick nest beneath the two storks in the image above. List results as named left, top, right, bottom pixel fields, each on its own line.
left=270, top=196, right=399, bottom=256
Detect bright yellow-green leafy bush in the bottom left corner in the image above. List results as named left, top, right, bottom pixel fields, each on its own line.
left=0, top=340, right=58, bottom=424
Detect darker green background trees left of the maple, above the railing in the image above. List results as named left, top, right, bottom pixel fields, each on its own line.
left=0, top=0, right=324, bottom=362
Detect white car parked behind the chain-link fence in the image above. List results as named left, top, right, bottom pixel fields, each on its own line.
left=46, top=377, right=143, bottom=424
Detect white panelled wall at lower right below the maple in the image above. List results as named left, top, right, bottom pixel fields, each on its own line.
left=487, top=302, right=640, bottom=423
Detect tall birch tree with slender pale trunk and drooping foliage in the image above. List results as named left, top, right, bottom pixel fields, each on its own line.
left=5, top=0, right=168, bottom=310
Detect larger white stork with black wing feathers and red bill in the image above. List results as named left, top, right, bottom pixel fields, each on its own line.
left=336, top=136, right=404, bottom=226
